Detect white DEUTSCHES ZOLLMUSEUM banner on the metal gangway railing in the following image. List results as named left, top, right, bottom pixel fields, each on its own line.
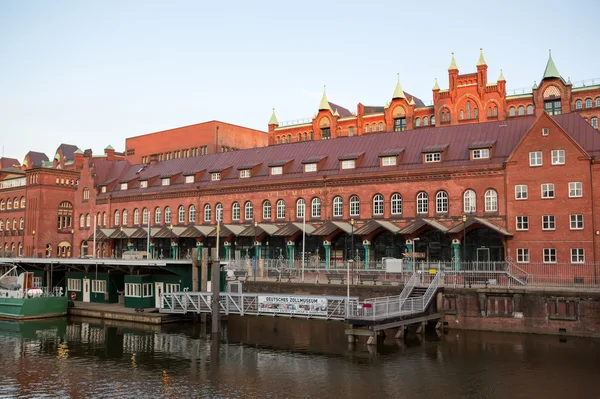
left=258, top=295, right=327, bottom=316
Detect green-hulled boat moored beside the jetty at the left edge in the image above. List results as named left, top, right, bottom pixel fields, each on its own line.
left=0, top=266, right=68, bottom=320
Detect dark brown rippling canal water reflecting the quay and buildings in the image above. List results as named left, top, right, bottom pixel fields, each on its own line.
left=0, top=317, right=600, bottom=399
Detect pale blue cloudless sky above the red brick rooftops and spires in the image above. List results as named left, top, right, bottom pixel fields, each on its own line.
left=0, top=0, right=600, bottom=161
